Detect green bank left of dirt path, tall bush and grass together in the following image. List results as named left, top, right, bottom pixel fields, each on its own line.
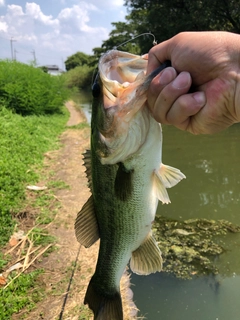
left=0, top=61, right=68, bottom=319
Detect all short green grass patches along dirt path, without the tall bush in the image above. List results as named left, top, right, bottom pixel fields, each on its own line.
left=0, top=107, right=68, bottom=319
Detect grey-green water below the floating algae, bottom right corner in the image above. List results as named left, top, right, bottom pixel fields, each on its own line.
left=132, top=273, right=240, bottom=320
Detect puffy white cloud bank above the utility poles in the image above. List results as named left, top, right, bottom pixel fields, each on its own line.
left=0, top=2, right=108, bottom=47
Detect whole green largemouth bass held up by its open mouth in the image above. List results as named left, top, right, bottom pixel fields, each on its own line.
left=75, top=50, right=185, bottom=320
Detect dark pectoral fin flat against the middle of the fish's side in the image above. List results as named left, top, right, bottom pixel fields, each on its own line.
left=114, top=162, right=133, bottom=201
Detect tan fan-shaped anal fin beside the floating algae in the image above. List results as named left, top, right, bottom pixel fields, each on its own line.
left=130, top=232, right=162, bottom=275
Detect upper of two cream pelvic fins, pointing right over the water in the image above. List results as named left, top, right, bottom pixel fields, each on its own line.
left=158, top=164, right=186, bottom=188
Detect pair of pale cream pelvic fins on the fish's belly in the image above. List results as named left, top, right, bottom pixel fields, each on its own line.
left=153, top=164, right=186, bottom=203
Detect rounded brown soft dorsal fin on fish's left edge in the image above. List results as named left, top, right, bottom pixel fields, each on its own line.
left=75, top=196, right=99, bottom=248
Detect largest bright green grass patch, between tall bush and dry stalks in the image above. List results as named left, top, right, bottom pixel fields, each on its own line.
left=0, top=107, right=68, bottom=245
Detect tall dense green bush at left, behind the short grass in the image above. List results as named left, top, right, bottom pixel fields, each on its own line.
left=0, top=60, right=68, bottom=116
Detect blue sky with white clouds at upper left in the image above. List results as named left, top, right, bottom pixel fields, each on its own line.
left=0, top=0, right=127, bottom=67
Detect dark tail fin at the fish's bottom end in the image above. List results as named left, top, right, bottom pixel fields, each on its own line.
left=84, top=278, right=123, bottom=320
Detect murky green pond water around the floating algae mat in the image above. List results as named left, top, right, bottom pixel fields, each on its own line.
left=78, top=90, right=240, bottom=320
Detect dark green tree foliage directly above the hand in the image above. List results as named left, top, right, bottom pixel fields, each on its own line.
left=125, top=0, right=240, bottom=52
